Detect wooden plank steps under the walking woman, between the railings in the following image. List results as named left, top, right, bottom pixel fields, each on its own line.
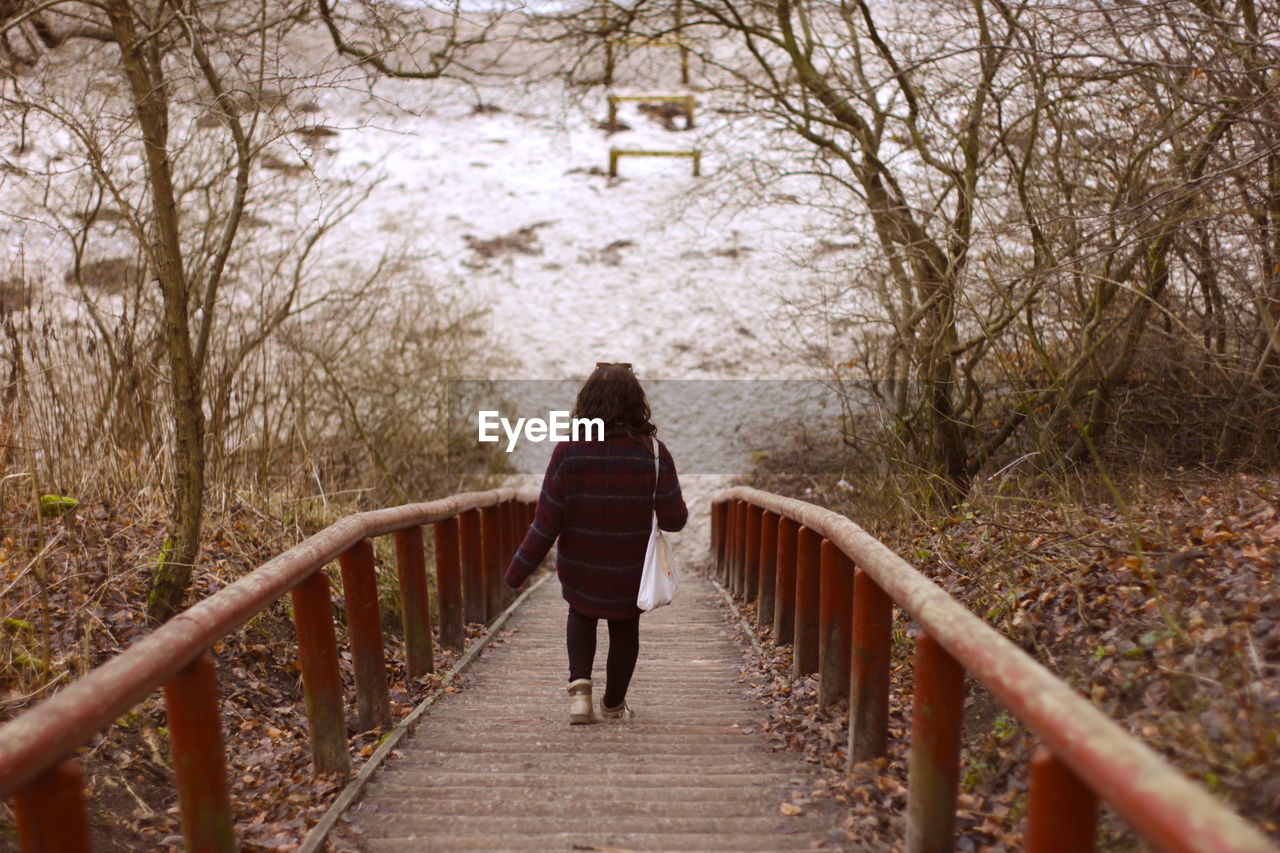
left=338, top=578, right=858, bottom=853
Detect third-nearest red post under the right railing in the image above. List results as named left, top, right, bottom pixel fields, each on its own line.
left=849, top=569, right=893, bottom=765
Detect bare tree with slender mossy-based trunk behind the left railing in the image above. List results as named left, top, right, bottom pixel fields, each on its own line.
left=0, top=0, right=504, bottom=621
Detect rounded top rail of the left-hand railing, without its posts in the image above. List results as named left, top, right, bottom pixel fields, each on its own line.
left=0, top=488, right=538, bottom=799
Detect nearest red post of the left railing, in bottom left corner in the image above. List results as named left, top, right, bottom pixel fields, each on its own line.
left=13, top=758, right=91, bottom=853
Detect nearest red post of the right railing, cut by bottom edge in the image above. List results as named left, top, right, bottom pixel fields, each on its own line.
left=1027, top=747, right=1098, bottom=853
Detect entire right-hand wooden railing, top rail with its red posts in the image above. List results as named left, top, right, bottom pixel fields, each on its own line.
left=712, top=487, right=1276, bottom=853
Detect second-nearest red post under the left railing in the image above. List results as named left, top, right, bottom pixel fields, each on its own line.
left=164, top=652, right=239, bottom=853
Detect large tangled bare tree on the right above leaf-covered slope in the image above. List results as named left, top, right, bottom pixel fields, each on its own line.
left=577, top=0, right=1280, bottom=503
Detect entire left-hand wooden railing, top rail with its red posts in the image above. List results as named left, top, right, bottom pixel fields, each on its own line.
left=0, top=489, right=538, bottom=850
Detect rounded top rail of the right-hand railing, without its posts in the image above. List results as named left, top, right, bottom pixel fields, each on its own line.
left=712, top=487, right=1276, bottom=853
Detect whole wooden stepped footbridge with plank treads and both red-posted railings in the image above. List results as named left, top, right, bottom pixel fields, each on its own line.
left=0, top=488, right=1276, bottom=853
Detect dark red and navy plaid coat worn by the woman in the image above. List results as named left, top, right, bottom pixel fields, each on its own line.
left=506, top=434, right=689, bottom=619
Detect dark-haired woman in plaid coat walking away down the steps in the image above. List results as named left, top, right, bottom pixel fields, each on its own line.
left=506, top=362, right=689, bottom=725
